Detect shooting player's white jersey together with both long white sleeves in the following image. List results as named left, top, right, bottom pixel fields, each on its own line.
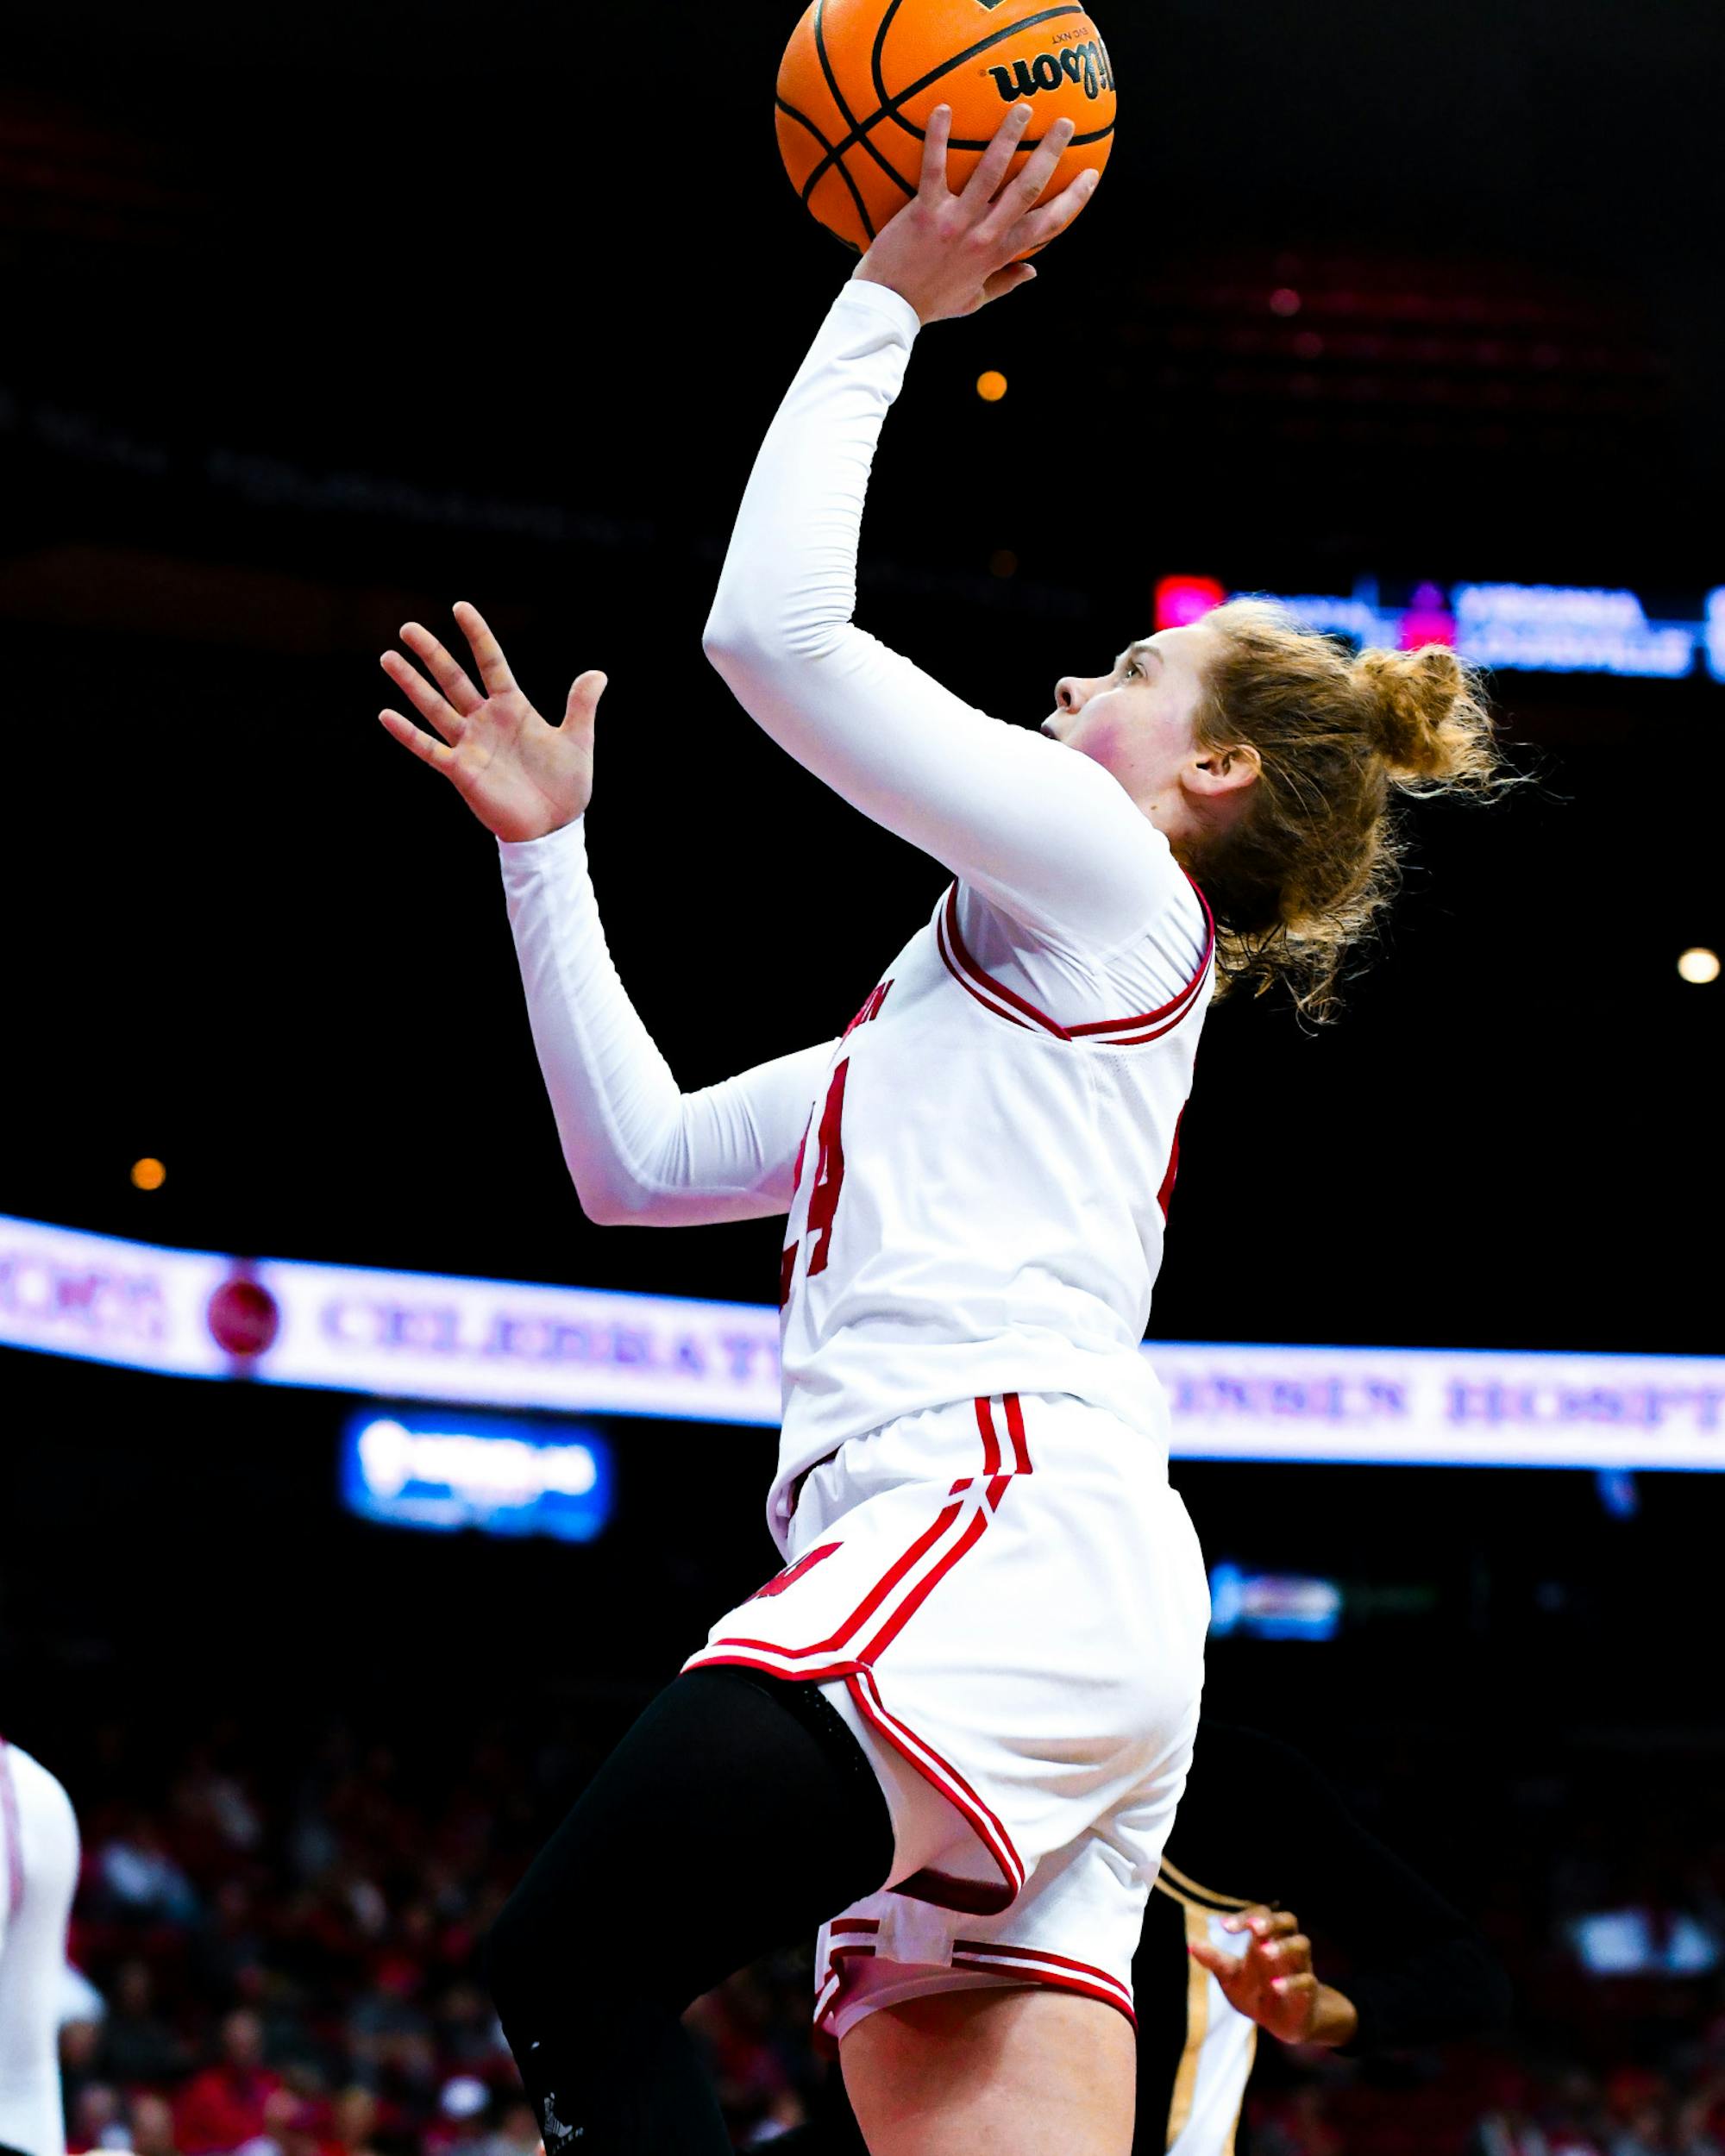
left=500, top=283, right=1214, bottom=1548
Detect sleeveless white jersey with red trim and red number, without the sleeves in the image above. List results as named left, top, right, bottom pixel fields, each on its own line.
left=770, top=887, right=1210, bottom=1539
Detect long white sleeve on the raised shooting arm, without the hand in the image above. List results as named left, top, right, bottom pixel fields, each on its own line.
left=706, top=280, right=1206, bottom=1000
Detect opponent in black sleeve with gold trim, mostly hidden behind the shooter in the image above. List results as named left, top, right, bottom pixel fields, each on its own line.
left=775, top=1714, right=1509, bottom=2156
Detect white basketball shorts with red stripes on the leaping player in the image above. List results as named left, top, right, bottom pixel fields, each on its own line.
left=686, top=1393, right=1210, bottom=2038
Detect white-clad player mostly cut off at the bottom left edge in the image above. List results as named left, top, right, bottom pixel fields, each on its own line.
left=0, top=1738, right=78, bottom=2156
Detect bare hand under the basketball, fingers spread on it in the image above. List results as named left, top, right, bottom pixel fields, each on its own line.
left=854, top=103, right=1095, bottom=323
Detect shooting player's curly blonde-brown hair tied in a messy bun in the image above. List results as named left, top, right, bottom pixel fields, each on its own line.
left=1189, top=599, right=1514, bottom=1022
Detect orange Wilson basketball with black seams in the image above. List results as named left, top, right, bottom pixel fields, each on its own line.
left=779, top=0, right=1115, bottom=253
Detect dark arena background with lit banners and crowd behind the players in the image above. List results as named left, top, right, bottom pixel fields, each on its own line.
left=0, top=0, right=1725, bottom=2156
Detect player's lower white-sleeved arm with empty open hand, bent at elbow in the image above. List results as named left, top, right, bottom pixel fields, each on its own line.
left=382, top=606, right=831, bottom=1227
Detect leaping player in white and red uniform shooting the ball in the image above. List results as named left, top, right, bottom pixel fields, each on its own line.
left=373, top=108, right=1490, bottom=2156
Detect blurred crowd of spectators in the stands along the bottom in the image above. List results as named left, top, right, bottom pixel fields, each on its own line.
left=43, top=1723, right=1725, bottom=2156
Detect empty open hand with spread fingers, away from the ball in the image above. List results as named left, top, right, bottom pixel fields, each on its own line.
left=378, top=599, right=606, bottom=843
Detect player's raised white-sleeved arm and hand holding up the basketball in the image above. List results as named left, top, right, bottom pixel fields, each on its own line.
left=706, top=108, right=1197, bottom=949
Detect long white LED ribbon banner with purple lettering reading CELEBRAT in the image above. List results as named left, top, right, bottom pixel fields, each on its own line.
left=0, top=1216, right=1725, bottom=1469
